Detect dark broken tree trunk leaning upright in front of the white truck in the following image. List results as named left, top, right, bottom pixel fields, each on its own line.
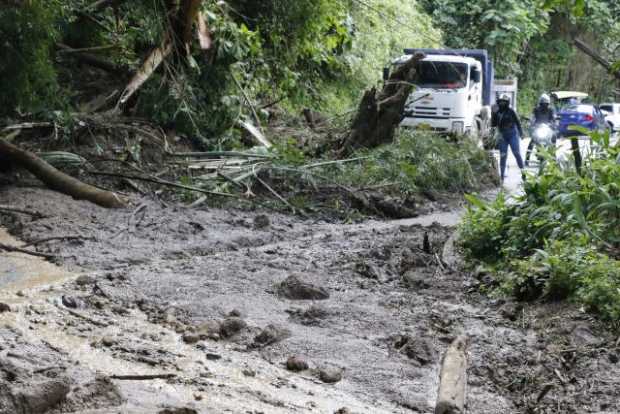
left=340, top=53, right=424, bottom=156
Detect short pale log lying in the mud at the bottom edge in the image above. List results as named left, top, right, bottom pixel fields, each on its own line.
left=435, top=336, right=468, bottom=414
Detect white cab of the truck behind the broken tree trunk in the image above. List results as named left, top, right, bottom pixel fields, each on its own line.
left=399, top=54, right=484, bottom=134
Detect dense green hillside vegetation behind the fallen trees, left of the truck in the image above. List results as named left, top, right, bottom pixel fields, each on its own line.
left=0, top=0, right=441, bottom=141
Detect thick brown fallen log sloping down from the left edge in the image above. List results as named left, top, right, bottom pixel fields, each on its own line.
left=0, top=139, right=126, bottom=208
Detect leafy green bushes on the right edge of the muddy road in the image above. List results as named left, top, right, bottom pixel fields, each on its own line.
left=459, top=129, right=620, bottom=320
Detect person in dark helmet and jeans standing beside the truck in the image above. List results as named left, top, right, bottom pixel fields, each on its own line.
left=491, top=94, right=525, bottom=182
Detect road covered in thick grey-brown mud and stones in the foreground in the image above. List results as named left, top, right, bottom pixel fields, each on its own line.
left=0, top=188, right=620, bottom=414
